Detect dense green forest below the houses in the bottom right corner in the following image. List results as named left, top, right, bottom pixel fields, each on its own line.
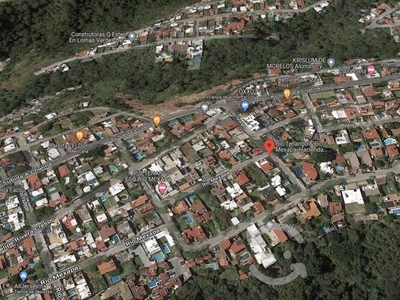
left=176, top=221, right=400, bottom=300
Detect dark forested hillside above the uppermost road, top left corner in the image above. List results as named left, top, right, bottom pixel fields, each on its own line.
left=0, top=0, right=197, bottom=59
